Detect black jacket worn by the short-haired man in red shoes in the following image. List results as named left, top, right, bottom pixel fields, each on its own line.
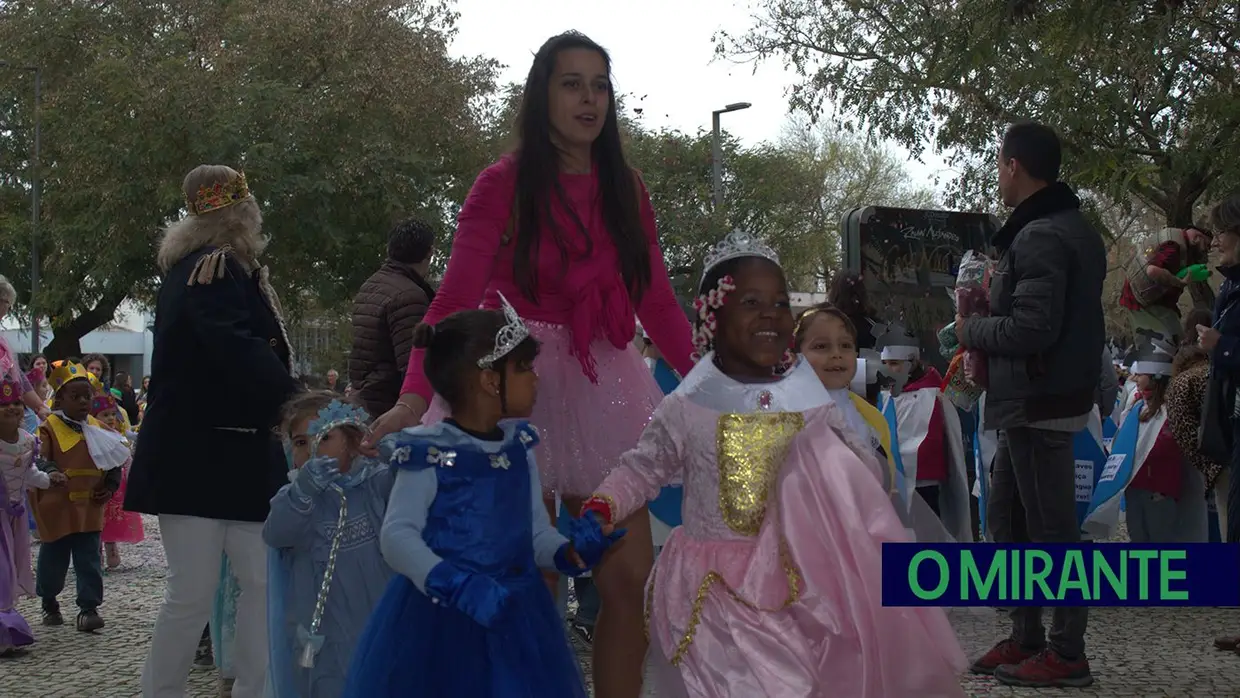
left=962, top=182, right=1106, bottom=429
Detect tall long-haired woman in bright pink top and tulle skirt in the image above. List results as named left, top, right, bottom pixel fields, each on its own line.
left=368, top=33, right=693, bottom=698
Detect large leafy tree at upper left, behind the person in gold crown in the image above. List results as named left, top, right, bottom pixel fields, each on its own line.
left=0, top=0, right=496, bottom=356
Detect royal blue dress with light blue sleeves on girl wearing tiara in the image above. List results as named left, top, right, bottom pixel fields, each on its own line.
left=343, top=422, right=587, bottom=698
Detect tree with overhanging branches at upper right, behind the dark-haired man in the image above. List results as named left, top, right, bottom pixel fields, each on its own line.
left=717, top=0, right=1240, bottom=227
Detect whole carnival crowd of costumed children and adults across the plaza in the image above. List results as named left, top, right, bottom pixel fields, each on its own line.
left=0, top=27, right=1240, bottom=698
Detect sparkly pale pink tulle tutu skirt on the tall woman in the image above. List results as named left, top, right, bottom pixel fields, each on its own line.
left=423, top=320, right=663, bottom=497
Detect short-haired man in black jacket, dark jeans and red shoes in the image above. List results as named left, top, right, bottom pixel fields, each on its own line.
left=956, top=123, right=1106, bottom=687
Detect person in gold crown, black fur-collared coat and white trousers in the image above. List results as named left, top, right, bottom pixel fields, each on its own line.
left=125, top=165, right=298, bottom=698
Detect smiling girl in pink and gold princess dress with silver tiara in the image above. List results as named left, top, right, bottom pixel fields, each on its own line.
left=583, top=233, right=966, bottom=698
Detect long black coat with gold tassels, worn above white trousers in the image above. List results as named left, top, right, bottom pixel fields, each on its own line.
left=125, top=248, right=298, bottom=522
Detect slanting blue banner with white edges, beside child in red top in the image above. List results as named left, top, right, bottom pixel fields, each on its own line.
left=1081, top=400, right=1167, bottom=541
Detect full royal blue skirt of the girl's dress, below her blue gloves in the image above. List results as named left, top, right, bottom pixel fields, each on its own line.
left=342, top=570, right=588, bottom=698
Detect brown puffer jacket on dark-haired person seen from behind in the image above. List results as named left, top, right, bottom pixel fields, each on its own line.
left=348, top=259, right=435, bottom=417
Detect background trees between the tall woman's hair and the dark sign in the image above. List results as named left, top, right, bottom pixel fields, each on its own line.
left=629, top=115, right=932, bottom=290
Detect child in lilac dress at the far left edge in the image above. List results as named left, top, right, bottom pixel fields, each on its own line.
left=0, top=376, right=64, bottom=656
